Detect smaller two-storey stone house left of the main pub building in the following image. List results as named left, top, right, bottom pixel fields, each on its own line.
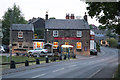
left=11, top=24, right=34, bottom=53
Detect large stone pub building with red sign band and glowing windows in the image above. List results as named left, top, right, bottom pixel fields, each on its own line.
left=45, top=18, right=90, bottom=55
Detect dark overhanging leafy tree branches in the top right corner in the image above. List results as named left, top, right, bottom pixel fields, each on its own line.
left=86, top=2, right=120, bottom=35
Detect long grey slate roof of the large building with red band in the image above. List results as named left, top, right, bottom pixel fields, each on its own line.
left=45, top=19, right=90, bottom=29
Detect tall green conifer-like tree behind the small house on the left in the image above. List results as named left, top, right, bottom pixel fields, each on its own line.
left=2, top=4, right=27, bottom=45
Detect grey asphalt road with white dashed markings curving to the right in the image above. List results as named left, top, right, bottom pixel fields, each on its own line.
left=2, top=47, right=118, bottom=79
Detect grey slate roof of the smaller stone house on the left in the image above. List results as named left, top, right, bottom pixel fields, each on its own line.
left=12, top=24, right=34, bottom=31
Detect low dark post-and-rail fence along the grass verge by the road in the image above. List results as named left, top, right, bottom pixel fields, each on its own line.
left=0, top=55, right=76, bottom=69
